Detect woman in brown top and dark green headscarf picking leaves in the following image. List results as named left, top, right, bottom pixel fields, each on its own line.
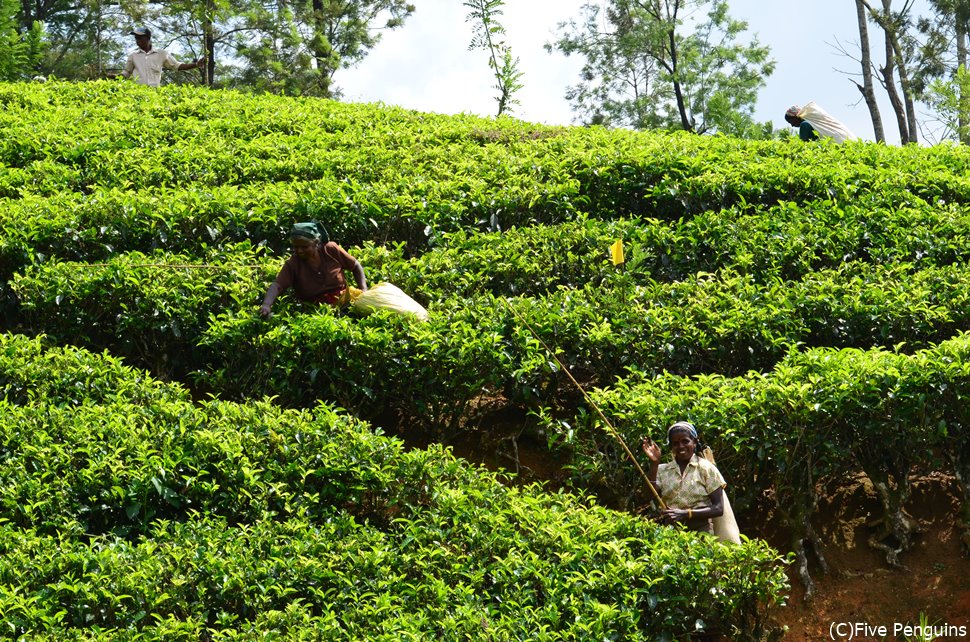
left=259, top=222, right=367, bottom=317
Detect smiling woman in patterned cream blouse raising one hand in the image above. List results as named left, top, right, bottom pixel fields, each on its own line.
left=641, top=421, right=726, bottom=535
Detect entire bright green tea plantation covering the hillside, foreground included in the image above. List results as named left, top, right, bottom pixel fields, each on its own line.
left=0, top=81, right=970, bottom=640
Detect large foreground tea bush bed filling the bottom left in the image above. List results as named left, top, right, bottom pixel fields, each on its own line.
left=0, top=337, right=787, bottom=640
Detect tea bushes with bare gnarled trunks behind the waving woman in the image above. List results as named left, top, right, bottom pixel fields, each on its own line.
left=572, top=334, right=970, bottom=587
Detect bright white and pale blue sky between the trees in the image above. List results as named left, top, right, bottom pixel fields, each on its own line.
left=334, top=0, right=925, bottom=144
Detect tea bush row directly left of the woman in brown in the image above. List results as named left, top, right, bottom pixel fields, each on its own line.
left=12, top=243, right=272, bottom=378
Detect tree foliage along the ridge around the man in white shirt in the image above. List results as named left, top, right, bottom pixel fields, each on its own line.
left=11, top=0, right=414, bottom=97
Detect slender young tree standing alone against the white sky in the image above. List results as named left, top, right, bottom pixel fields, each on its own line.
left=465, top=0, right=522, bottom=116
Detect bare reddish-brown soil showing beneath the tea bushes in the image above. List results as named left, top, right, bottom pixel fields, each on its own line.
left=412, top=424, right=970, bottom=642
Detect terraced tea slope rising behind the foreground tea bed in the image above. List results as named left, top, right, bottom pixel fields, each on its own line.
left=0, top=82, right=970, bottom=628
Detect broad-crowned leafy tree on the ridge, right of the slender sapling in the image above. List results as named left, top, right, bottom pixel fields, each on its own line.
left=546, top=0, right=775, bottom=133
